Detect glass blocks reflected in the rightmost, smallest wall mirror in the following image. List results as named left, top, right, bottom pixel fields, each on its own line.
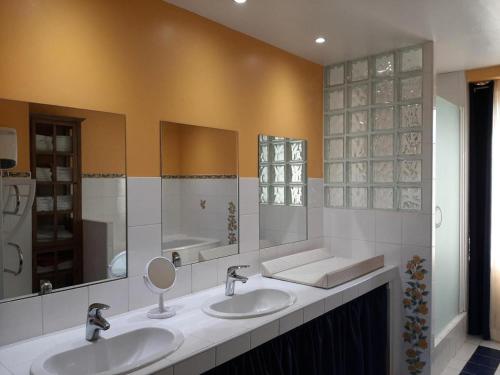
left=259, top=135, right=307, bottom=206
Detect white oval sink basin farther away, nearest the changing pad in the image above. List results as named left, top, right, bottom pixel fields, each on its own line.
left=203, top=289, right=297, bottom=319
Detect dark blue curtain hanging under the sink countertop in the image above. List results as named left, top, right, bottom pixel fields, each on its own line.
left=206, top=286, right=389, bottom=375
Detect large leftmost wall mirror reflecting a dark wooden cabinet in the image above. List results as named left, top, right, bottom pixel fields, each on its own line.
left=0, top=99, right=127, bottom=301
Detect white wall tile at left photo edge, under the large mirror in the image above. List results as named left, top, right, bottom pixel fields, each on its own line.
left=0, top=297, right=42, bottom=346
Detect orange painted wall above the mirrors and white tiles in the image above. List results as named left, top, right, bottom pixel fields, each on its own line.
left=0, top=0, right=323, bottom=177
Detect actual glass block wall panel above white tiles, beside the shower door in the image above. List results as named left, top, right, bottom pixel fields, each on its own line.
left=324, top=46, right=423, bottom=211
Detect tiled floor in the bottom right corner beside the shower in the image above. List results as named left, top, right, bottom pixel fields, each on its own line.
left=441, top=337, right=500, bottom=375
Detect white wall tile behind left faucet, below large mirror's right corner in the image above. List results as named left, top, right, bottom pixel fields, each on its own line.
left=89, top=279, right=128, bottom=317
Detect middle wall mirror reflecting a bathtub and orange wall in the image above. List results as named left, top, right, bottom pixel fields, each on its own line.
left=161, top=122, right=238, bottom=267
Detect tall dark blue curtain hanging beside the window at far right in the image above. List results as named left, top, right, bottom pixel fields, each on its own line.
left=468, top=82, right=494, bottom=340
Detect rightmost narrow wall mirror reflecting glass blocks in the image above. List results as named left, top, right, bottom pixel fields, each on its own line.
left=258, top=135, right=307, bottom=249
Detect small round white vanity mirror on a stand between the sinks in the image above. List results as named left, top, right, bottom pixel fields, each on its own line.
left=144, top=257, right=176, bottom=319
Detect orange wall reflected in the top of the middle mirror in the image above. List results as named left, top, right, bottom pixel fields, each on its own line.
left=161, top=123, right=238, bottom=176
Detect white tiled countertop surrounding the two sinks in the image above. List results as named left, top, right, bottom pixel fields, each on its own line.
left=0, top=266, right=399, bottom=375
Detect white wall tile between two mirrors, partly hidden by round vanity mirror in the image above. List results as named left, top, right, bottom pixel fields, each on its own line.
left=128, top=224, right=161, bottom=277
